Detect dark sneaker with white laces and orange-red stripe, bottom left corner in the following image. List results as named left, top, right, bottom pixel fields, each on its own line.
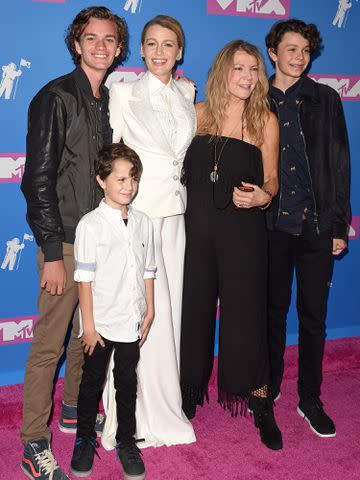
left=21, top=438, right=70, bottom=480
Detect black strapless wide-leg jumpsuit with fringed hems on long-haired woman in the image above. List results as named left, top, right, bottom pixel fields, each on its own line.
left=180, top=135, right=269, bottom=415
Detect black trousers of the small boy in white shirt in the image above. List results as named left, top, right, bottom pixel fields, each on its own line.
left=76, top=338, right=139, bottom=443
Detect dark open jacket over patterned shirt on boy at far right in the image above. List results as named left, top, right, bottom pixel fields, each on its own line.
left=267, top=76, right=350, bottom=240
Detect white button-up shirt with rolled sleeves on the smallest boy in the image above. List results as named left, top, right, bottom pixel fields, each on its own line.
left=74, top=200, right=156, bottom=342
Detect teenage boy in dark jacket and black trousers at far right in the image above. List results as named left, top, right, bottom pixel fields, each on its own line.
left=266, top=20, right=350, bottom=437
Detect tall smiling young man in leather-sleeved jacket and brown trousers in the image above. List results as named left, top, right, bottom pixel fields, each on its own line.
left=21, top=7, right=128, bottom=480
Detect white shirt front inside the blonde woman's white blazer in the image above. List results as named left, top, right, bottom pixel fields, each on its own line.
left=148, top=72, right=192, bottom=155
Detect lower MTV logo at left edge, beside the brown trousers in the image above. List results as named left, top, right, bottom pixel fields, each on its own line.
left=0, top=317, right=37, bottom=346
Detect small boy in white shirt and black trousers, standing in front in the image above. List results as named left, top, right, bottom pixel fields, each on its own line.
left=71, top=144, right=156, bottom=480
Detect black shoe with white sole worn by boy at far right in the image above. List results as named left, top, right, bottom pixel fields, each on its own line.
left=297, top=397, right=336, bottom=438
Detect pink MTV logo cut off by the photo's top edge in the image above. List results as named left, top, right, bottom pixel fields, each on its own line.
left=207, top=0, right=290, bottom=19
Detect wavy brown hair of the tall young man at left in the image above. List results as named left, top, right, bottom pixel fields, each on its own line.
left=65, top=7, right=129, bottom=67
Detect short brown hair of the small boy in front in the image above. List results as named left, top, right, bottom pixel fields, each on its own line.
left=95, top=143, right=143, bottom=181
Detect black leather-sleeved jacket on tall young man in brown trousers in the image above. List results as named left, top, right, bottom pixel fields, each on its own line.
left=21, top=67, right=108, bottom=261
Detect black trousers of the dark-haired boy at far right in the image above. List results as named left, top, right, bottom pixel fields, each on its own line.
left=268, top=228, right=333, bottom=399
